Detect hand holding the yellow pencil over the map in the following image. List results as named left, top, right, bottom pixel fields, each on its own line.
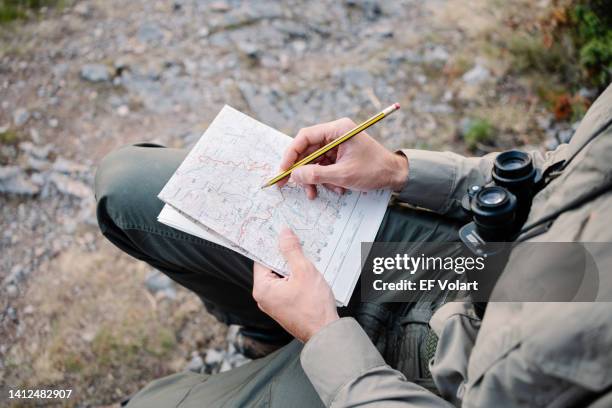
left=278, top=118, right=408, bottom=199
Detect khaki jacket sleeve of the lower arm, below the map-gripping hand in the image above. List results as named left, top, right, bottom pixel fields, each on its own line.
left=300, top=318, right=452, bottom=408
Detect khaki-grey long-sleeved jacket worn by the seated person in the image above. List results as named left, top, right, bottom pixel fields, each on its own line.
left=301, top=86, right=612, bottom=407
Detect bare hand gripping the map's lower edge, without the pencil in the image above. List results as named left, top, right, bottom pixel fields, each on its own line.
left=253, top=229, right=338, bottom=343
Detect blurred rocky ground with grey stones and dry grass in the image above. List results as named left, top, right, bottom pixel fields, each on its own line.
left=0, top=0, right=590, bottom=406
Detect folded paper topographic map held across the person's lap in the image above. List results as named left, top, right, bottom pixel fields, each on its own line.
left=158, top=106, right=390, bottom=305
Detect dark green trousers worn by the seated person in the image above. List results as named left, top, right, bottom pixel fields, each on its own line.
left=95, top=144, right=459, bottom=407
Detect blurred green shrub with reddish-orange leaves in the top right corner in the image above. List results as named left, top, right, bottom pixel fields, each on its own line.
left=500, top=0, right=612, bottom=122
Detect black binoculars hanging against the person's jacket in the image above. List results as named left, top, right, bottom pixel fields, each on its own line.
left=459, top=150, right=537, bottom=250
